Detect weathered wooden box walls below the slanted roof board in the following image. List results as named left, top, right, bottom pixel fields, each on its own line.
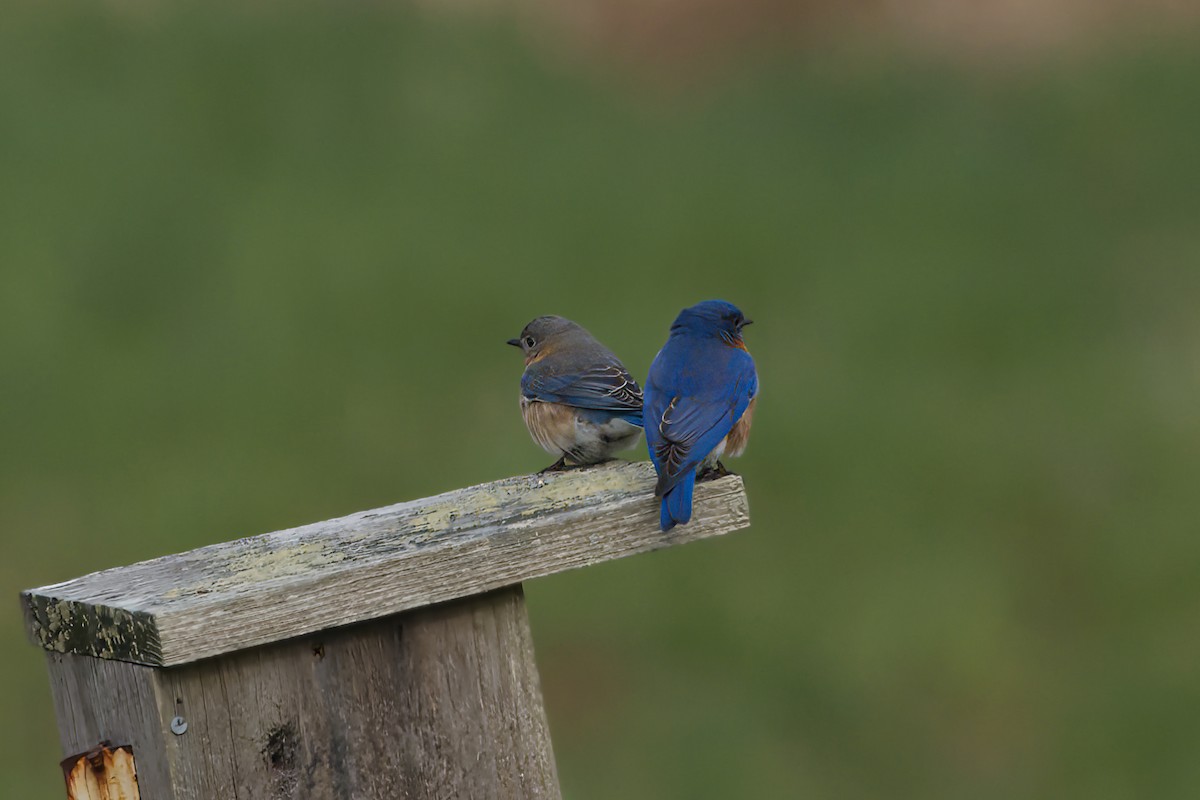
left=50, top=587, right=559, bottom=800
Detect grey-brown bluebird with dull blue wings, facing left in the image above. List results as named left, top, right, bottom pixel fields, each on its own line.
left=509, top=317, right=642, bottom=471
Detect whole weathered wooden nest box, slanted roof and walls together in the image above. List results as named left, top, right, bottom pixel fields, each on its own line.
left=22, top=463, right=749, bottom=800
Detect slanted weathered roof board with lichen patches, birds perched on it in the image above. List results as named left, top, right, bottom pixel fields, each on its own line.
left=22, top=462, right=750, bottom=666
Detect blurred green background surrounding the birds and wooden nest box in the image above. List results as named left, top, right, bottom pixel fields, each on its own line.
left=0, top=2, right=1200, bottom=800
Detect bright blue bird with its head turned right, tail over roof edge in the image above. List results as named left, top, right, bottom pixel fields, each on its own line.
left=644, top=300, right=758, bottom=530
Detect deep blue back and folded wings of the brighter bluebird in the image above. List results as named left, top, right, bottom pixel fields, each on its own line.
left=646, top=348, right=758, bottom=497
